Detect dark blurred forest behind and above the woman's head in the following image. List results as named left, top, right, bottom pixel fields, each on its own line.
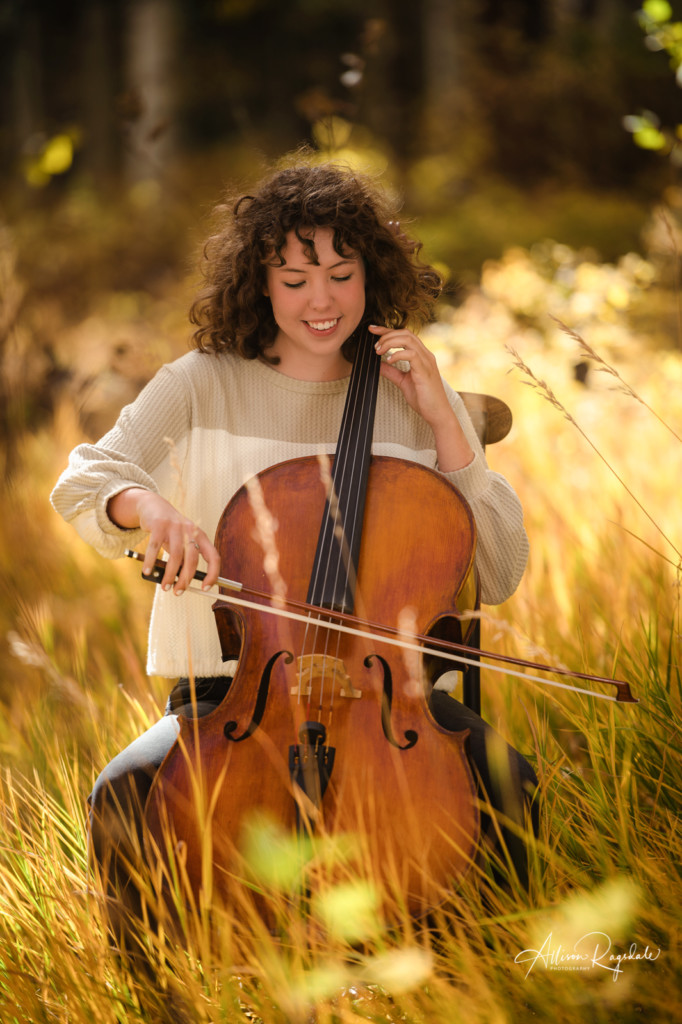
left=0, top=0, right=682, bottom=448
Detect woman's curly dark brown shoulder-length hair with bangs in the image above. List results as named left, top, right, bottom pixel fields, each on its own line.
left=189, top=164, right=442, bottom=361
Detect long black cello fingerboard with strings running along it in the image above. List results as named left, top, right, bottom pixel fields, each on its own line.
left=307, top=325, right=381, bottom=612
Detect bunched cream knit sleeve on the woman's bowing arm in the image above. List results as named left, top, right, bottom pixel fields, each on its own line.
left=50, top=367, right=188, bottom=558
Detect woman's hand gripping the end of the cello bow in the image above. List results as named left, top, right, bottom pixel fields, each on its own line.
left=106, top=487, right=220, bottom=596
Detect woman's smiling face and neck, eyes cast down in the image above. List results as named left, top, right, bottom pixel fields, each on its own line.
left=265, top=227, right=365, bottom=380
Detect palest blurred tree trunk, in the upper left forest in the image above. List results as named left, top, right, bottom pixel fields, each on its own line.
left=125, top=0, right=177, bottom=181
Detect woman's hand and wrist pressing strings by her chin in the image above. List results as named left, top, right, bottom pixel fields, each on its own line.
left=370, top=324, right=474, bottom=473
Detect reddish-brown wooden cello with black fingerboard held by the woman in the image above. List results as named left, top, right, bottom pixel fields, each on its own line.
left=145, top=323, right=479, bottom=915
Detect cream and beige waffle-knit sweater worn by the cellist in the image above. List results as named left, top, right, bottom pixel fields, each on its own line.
left=51, top=351, right=528, bottom=677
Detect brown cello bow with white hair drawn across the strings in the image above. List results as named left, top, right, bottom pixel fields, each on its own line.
left=125, top=549, right=639, bottom=703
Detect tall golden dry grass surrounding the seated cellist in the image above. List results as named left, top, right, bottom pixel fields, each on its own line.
left=0, top=220, right=682, bottom=1024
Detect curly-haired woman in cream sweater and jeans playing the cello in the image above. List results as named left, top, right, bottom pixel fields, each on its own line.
left=52, top=165, right=537, bottom=950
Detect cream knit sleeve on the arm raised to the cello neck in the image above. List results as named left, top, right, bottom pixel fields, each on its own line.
left=443, top=386, right=528, bottom=604
